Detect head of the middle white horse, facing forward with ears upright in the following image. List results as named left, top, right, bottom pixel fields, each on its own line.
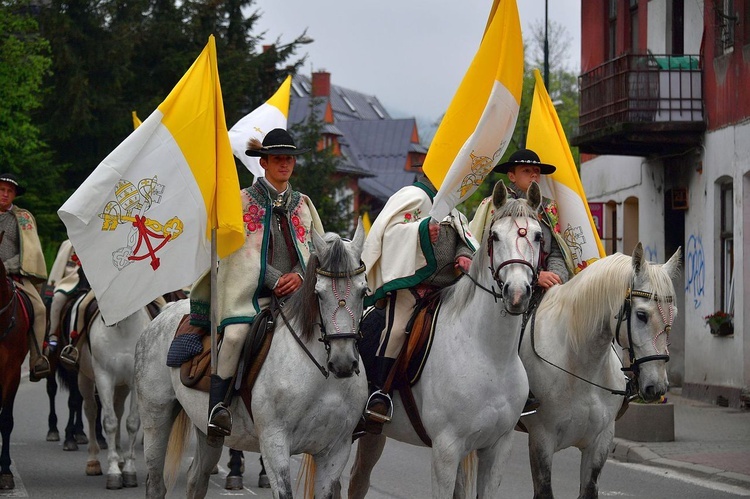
left=486, top=181, right=542, bottom=314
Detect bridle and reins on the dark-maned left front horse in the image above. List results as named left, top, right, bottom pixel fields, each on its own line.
left=278, top=263, right=365, bottom=378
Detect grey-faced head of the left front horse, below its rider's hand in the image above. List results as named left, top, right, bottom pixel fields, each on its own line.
left=313, top=221, right=367, bottom=378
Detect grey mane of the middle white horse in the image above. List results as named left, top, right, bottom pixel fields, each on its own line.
left=441, top=198, right=537, bottom=311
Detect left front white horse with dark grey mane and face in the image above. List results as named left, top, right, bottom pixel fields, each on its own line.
left=136, top=228, right=367, bottom=498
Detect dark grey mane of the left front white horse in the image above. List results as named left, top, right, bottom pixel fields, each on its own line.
left=284, top=232, right=358, bottom=341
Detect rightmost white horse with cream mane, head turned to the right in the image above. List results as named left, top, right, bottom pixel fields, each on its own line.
left=520, top=243, right=680, bottom=498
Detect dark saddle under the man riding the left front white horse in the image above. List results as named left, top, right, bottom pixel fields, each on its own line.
left=167, top=309, right=276, bottom=417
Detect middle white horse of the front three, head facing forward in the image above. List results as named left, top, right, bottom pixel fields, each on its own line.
left=349, top=182, right=542, bottom=499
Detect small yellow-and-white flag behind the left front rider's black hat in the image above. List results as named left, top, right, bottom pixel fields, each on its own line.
left=229, top=76, right=292, bottom=177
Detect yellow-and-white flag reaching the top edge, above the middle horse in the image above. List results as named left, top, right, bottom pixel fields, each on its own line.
left=422, top=0, right=523, bottom=220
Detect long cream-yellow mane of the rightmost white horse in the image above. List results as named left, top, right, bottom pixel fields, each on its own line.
left=539, top=253, right=675, bottom=352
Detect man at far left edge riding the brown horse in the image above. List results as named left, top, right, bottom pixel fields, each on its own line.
left=0, top=173, right=50, bottom=381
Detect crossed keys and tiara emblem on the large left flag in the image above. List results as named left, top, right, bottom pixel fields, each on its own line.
left=99, top=175, right=184, bottom=270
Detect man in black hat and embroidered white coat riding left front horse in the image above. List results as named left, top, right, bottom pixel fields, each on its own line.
left=190, top=128, right=323, bottom=438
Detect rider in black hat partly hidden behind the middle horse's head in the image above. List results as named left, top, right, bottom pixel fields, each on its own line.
left=469, top=149, right=573, bottom=413
